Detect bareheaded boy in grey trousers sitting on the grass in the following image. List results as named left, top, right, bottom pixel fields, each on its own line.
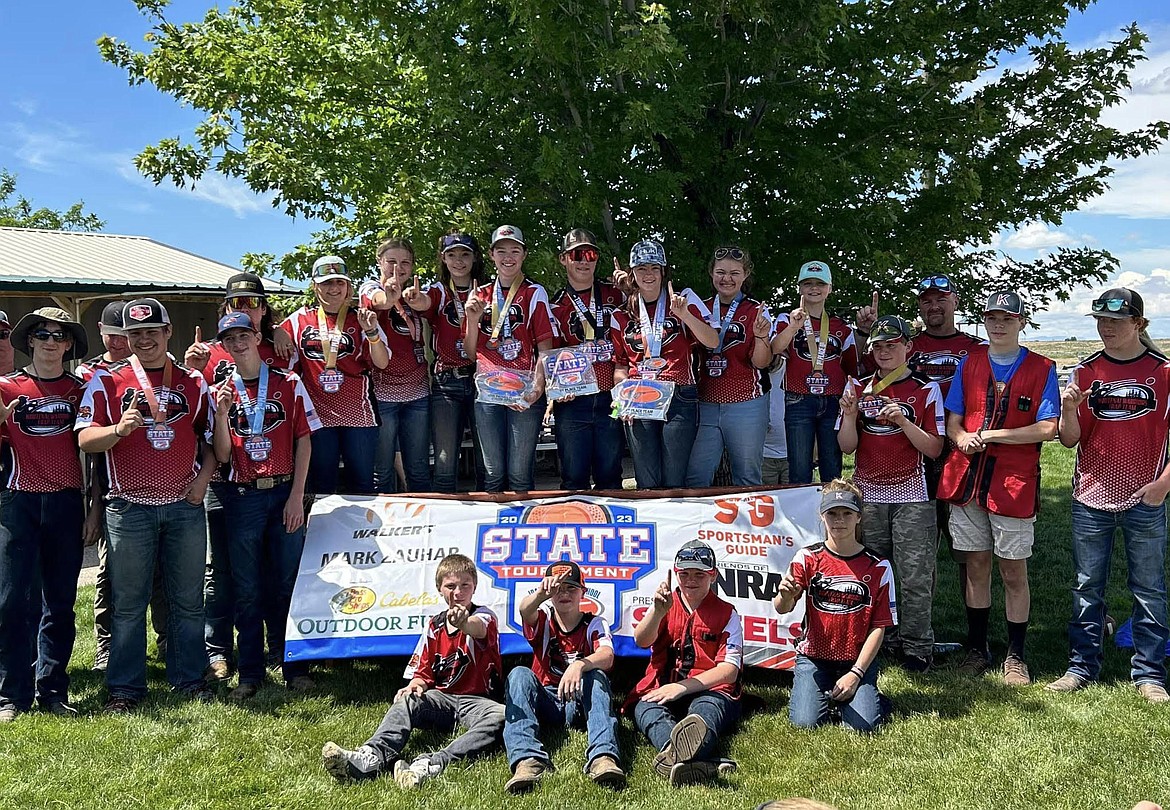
left=321, top=554, right=504, bottom=788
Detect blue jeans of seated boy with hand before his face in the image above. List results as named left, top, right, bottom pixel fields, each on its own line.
left=504, top=666, right=620, bottom=771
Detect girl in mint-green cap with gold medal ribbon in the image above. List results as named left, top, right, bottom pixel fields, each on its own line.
left=772, top=261, right=858, bottom=483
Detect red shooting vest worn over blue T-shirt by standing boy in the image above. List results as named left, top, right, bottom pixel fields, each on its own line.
left=938, top=345, right=1053, bottom=517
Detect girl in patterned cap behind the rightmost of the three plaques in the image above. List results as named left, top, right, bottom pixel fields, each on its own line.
left=610, top=239, right=716, bottom=489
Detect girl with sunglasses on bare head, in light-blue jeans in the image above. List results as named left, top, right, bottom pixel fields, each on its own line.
left=687, top=245, right=772, bottom=488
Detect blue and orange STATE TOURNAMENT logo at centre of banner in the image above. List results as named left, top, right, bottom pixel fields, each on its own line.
left=476, top=500, right=658, bottom=632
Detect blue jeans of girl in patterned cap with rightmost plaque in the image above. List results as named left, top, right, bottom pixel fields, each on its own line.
left=626, top=385, right=697, bottom=489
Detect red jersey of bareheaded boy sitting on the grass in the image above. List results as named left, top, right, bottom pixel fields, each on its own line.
left=405, top=605, right=503, bottom=698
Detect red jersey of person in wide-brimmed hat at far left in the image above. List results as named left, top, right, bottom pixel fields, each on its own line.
left=0, top=370, right=85, bottom=493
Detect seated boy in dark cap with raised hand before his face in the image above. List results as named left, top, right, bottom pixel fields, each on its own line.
left=504, top=561, right=626, bottom=794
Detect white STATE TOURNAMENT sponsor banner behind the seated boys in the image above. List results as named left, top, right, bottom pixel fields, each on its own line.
left=285, top=486, right=824, bottom=668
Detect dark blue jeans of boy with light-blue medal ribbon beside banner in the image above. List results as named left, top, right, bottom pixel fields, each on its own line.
left=223, top=483, right=309, bottom=684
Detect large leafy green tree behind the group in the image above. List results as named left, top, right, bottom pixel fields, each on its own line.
left=99, top=0, right=1170, bottom=316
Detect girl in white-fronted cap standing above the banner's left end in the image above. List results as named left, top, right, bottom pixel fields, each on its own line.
left=280, top=256, right=390, bottom=494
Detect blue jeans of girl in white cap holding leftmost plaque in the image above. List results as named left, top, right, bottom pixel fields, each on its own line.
left=475, top=397, right=545, bottom=492
